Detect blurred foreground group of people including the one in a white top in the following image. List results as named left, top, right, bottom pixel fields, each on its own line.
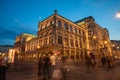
left=38, top=52, right=67, bottom=80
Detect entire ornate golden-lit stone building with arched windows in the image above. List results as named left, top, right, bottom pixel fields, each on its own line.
left=15, top=10, right=111, bottom=60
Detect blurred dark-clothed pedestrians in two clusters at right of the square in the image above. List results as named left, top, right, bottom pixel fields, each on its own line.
left=85, top=53, right=113, bottom=73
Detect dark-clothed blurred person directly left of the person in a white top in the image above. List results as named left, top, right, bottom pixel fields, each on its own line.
left=43, top=54, right=50, bottom=80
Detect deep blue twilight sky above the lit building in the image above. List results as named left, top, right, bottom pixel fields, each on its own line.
left=0, top=0, right=120, bottom=45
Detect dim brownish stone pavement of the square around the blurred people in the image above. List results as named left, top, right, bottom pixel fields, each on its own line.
left=6, top=60, right=120, bottom=80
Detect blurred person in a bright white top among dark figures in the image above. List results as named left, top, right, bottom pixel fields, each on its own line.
left=50, top=52, right=56, bottom=78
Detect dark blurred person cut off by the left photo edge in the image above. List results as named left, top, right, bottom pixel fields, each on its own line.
left=0, top=57, right=9, bottom=80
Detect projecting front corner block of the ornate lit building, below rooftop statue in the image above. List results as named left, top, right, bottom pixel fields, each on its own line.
left=38, top=14, right=86, bottom=59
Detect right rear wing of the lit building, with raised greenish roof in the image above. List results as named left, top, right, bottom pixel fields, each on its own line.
left=75, top=16, right=112, bottom=56
